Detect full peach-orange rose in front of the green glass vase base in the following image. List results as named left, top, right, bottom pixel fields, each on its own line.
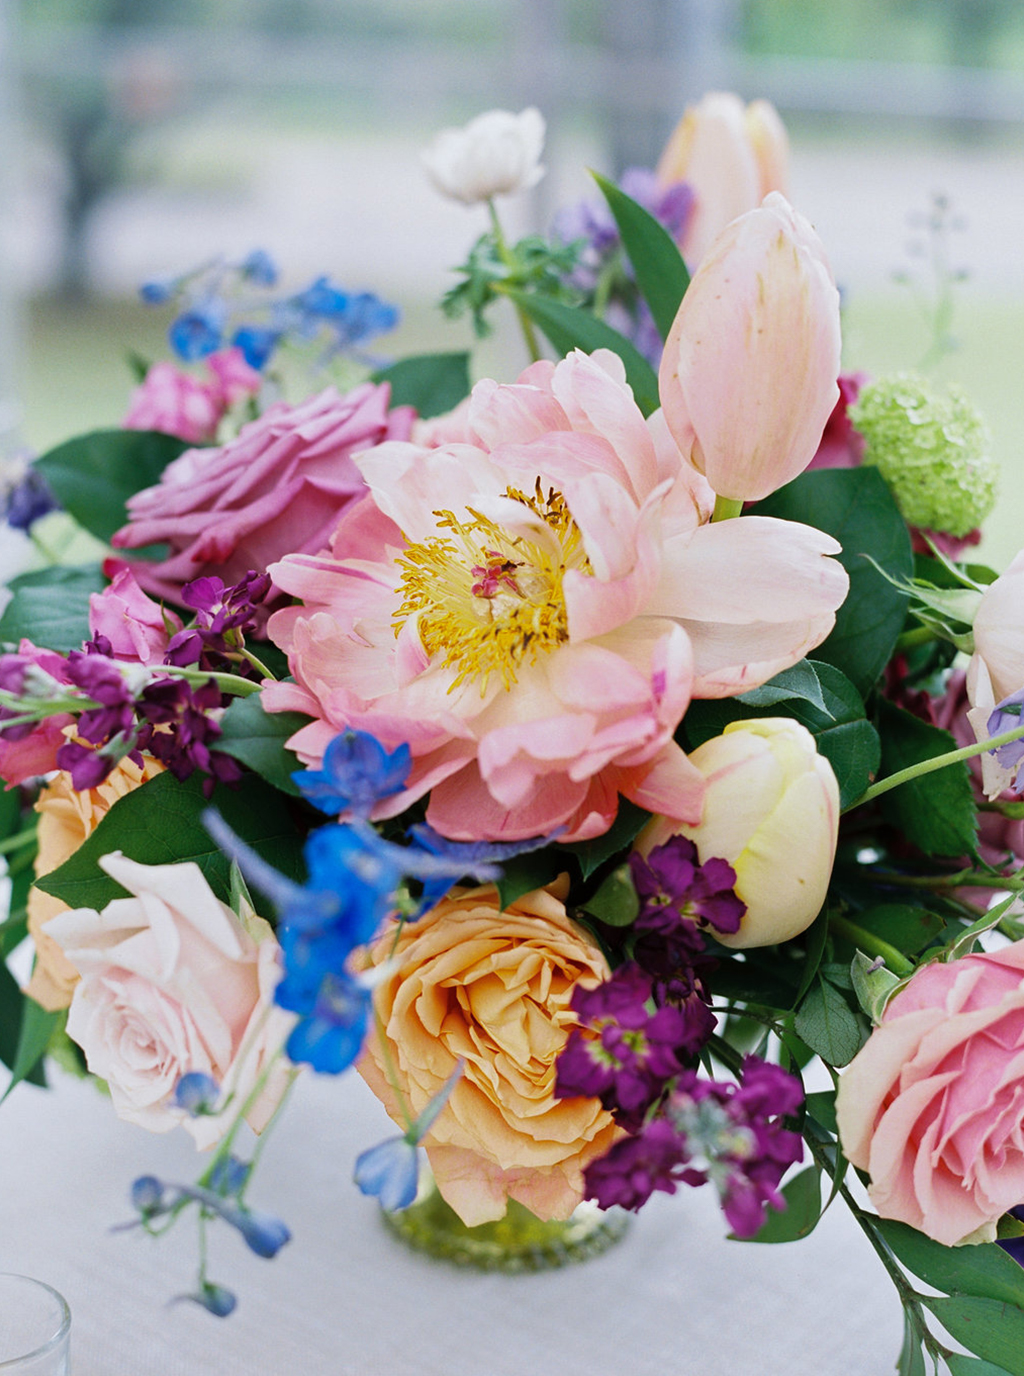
left=358, top=888, right=618, bottom=1226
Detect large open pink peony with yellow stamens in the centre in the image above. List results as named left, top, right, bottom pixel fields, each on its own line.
left=263, top=351, right=846, bottom=839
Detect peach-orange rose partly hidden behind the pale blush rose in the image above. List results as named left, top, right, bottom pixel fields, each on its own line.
left=25, top=755, right=164, bottom=1013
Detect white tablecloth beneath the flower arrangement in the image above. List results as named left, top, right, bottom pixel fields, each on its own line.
left=0, top=1075, right=900, bottom=1376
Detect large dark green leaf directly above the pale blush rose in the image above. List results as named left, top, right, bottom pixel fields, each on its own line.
left=36, top=772, right=304, bottom=916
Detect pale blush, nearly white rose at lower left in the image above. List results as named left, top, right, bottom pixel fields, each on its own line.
left=47, top=852, right=293, bottom=1148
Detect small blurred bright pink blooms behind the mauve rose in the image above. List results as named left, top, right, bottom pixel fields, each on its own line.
left=121, top=348, right=262, bottom=444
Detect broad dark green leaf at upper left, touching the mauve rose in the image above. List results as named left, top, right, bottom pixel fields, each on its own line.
left=36, top=431, right=193, bottom=544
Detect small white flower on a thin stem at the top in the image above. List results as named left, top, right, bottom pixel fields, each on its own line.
left=423, top=106, right=544, bottom=205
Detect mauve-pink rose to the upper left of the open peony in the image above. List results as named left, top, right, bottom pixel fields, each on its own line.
left=113, top=383, right=412, bottom=599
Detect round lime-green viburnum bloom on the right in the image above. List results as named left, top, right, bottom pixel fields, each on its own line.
left=849, top=373, right=996, bottom=537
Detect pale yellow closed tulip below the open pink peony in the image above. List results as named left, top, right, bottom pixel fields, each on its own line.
left=637, top=717, right=840, bottom=949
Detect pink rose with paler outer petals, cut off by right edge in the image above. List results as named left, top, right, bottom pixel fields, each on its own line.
left=837, top=941, right=1024, bottom=1247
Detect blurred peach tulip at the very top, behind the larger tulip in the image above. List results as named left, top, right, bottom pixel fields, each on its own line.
left=658, top=91, right=789, bottom=268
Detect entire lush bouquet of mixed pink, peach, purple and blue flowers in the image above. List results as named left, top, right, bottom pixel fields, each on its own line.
left=0, top=95, right=1024, bottom=1376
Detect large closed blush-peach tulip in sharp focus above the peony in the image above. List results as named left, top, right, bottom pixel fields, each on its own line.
left=658, top=193, right=840, bottom=501
